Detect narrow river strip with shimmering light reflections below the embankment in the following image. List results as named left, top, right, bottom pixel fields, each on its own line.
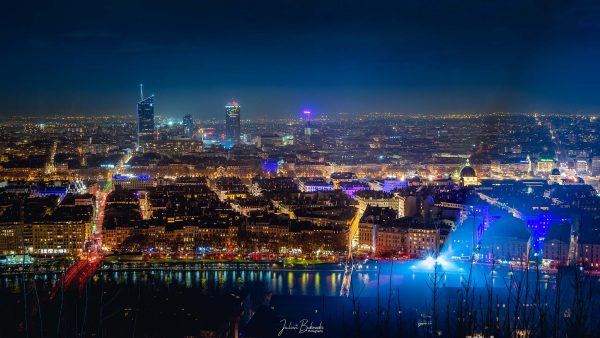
left=0, top=262, right=572, bottom=296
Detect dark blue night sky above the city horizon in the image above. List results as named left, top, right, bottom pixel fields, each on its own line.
left=0, top=0, right=600, bottom=118
